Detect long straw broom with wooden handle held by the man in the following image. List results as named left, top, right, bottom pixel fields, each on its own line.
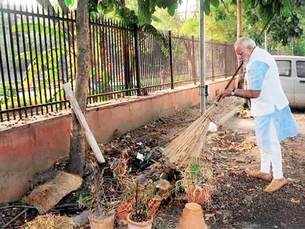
left=164, top=63, right=243, bottom=168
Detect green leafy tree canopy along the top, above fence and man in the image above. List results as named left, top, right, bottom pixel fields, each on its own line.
left=44, top=0, right=305, bottom=45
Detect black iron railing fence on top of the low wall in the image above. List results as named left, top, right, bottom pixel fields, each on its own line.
left=0, top=5, right=236, bottom=121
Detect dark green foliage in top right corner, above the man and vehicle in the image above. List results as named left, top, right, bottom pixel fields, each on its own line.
left=244, top=0, right=304, bottom=45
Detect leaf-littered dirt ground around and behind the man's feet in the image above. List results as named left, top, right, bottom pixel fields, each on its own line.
left=156, top=108, right=305, bottom=228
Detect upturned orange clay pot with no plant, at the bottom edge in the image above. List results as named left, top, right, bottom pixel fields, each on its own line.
left=178, top=203, right=207, bottom=229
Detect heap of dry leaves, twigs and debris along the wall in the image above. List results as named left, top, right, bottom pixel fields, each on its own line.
left=0, top=98, right=242, bottom=228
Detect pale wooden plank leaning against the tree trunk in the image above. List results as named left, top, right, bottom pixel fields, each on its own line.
left=63, top=83, right=105, bottom=163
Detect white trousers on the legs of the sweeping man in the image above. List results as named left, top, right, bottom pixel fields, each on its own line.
left=258, top=120, right=283, bottom=179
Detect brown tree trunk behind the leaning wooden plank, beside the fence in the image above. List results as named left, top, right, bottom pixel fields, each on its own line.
left=70, top=0, right=90, bottom=176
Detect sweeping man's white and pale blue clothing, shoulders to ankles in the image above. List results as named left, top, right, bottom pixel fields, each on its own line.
left=246, top=47, right=298, bottom=179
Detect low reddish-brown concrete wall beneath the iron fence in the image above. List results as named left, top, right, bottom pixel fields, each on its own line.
left=0, top=78, right=233, bottom=203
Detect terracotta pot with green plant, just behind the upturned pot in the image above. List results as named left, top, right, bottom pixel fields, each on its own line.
left=186, top=185, right=211, bottom=205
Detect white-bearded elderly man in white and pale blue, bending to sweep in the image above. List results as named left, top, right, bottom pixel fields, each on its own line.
left=222, top=38, right=298, bottom=193
